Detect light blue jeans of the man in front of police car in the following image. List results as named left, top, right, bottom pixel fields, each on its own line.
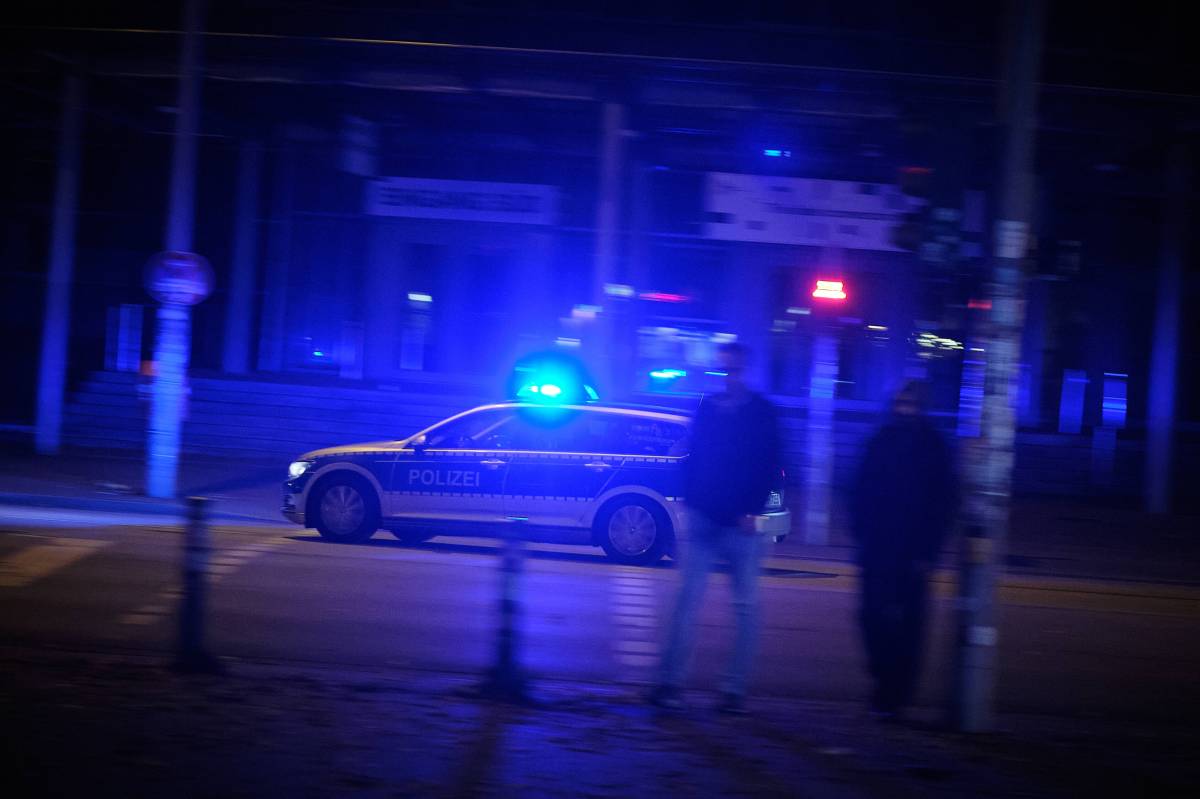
left=659, top=511, right=764, bottom=696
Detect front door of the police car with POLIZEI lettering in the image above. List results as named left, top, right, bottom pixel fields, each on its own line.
left=390, top=408, right=512, bottom=531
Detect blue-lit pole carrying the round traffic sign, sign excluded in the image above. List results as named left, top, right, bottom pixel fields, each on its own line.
left=146, top=0, right=203, bottom=498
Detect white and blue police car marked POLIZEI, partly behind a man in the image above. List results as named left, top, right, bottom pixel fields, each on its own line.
left=283, top=402, right=791, bottom=565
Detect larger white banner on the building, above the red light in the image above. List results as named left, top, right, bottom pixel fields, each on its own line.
left=704, top=172, right=923, bottom=252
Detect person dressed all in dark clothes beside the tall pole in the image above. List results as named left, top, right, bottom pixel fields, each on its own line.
left=851, top=383, right=958, bottom=720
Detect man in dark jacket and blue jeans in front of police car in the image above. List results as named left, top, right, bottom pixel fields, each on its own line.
left=650, top=343, right=782, bottom=713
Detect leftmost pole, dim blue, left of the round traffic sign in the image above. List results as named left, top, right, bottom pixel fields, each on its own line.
left=34, top=74, right=83, bottom=455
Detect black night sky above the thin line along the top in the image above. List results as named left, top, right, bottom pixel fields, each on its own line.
left=10, top=0, right=1200, bottom=94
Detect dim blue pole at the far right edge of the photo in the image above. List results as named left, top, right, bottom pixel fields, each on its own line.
left=1146, top=138, right=1192, bottom=513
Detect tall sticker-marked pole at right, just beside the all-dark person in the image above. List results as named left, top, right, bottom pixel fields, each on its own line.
left=952, top=0, right=1045, bottom=732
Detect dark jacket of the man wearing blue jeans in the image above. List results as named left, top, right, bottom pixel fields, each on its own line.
left=684, top=392, right=782, bottom=525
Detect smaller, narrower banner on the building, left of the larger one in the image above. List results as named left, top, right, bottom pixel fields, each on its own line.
left=366, top=178, right=558, bottom=224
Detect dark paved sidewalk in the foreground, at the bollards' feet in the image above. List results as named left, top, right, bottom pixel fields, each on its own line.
left=0, top=649, right=1200, bottom=798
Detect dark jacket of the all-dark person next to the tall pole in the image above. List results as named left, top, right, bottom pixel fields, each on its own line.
left=851, top=415, right=959, bottom=571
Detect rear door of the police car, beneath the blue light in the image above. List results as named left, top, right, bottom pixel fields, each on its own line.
left=504, top=409, right=623, bottom=528
